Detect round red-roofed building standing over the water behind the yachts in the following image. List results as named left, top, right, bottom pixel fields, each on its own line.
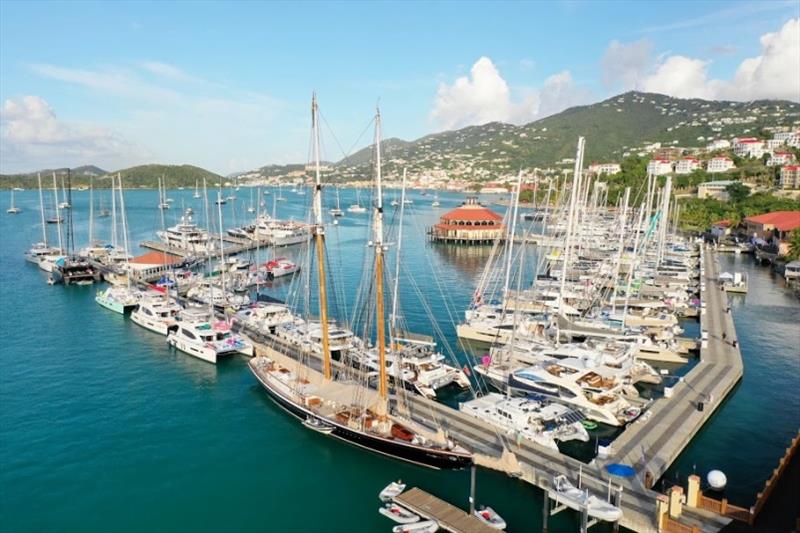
left=428, top=196, right=505, bottom=244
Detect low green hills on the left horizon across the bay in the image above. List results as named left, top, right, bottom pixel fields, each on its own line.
left=0, top=164, right=224, bottom=189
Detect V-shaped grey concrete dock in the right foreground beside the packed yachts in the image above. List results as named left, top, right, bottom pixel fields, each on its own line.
left=246, top=243, right=743, bottom=532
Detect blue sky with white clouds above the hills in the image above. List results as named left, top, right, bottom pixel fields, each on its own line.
left=0, top=0, right=800, bottom=174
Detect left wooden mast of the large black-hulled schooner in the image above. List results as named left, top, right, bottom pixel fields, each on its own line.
left=311, top=93, right=331, bottom=379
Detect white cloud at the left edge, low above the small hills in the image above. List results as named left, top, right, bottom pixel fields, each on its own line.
left=0, top=96, right=147, bottom=173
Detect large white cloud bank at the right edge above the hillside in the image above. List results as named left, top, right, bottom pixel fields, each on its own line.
left=602, top=18, right=800, bottom=101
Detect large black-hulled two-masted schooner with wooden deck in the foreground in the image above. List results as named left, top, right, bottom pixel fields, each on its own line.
left=249, top=95, right=472, bottom=469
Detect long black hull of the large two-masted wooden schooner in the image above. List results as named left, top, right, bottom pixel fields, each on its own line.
left=250, top=362, right=472, bottom=470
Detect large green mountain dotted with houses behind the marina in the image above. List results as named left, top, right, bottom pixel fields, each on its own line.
left=326, top=92, right=800, bottom=179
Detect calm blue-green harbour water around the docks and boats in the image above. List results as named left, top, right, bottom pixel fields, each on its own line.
left=0, top=189, right=800, bottom=532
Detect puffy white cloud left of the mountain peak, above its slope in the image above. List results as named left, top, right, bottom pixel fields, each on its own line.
left=430, top=57, right=590, bottom=129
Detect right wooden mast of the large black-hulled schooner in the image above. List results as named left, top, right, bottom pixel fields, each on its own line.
left=372, top=108, right=389, bottom=410
